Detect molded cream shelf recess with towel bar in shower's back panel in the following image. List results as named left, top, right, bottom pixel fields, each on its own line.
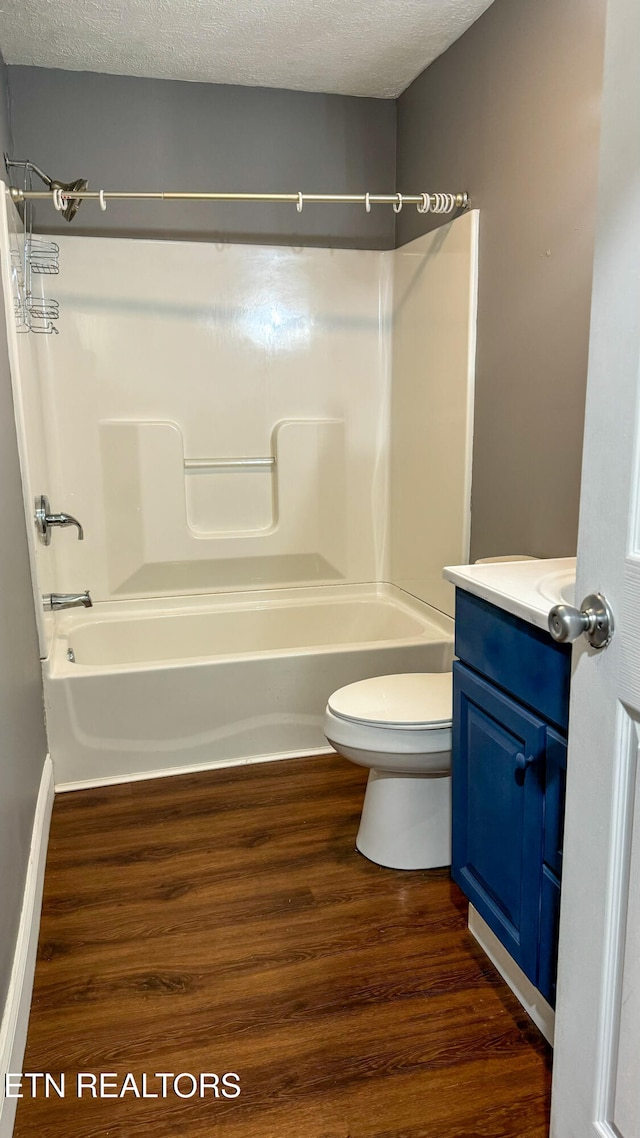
left=100, top=418, right=346, bottom=595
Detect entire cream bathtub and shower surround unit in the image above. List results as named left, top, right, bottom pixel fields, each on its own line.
left=0, top=186, right=477, bottom=787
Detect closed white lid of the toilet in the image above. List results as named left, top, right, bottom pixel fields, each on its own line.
left=328, top=671, right=453, bottom=729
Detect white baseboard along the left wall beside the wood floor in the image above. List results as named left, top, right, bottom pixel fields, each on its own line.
left=0, top=756, right=54, bottom=1138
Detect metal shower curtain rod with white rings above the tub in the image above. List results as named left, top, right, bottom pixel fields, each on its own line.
left=9, top=185, right=469, bottom=214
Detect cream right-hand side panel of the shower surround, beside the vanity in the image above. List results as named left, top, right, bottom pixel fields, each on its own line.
left=387, top=211, right=478, bottom=616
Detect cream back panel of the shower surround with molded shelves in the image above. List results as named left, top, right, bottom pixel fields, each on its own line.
left=35, top=237, right=391, bottom=600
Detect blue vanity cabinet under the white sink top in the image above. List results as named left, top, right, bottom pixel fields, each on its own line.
left=452, top=589, right=571, bottom=1004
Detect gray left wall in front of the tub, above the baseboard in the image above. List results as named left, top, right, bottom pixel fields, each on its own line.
left=0, top=48, right=47, bottom=1017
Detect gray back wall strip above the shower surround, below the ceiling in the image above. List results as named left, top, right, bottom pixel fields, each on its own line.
left=8, top=67, right=395, bottom=249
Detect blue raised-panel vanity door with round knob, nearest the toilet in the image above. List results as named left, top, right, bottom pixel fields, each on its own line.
left=452, top=663, right=547, bottom=983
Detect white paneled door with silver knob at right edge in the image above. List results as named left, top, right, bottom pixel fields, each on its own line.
left=551, top=0, right=640, bottom=1138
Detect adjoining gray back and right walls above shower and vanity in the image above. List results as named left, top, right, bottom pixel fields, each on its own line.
left=8, top=0, right=606, bottom=558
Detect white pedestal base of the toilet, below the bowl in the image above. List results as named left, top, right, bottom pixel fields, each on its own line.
left=355, top=769, right=451, bottom=869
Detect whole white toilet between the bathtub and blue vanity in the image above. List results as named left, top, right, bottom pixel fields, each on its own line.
left=325, top=673, right=452, bottom=869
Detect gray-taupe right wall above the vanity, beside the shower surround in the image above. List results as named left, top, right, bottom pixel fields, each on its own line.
left=397, top=0, right=606, bottom=558
